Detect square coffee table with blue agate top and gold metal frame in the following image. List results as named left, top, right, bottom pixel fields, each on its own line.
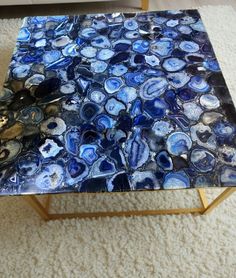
left=0, top=10, right=236, bottom=220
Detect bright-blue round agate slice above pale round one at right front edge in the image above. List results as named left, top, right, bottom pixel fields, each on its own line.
left=166, top=132, right=192, bottom=156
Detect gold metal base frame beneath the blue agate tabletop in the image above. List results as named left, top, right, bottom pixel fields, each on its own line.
left=24, top=187, right=236, bottom=221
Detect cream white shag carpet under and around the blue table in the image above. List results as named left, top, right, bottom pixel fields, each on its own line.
left=0, top=6, right=236, bottom=278
